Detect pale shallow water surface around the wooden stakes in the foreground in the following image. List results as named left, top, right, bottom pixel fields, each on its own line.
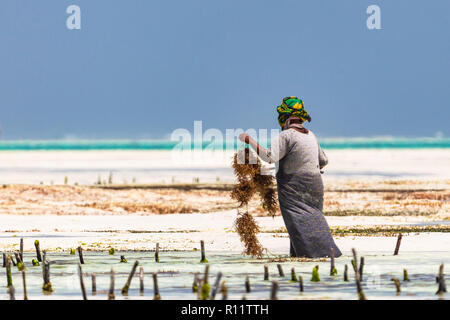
left=0, top=251, right=450, bottom=300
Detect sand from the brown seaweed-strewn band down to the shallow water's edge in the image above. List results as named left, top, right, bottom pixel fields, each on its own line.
left=0, top=180, right=450, bottom=254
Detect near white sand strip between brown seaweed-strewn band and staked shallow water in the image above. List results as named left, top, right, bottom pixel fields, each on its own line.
left=0, top=211, right=450, bottom=255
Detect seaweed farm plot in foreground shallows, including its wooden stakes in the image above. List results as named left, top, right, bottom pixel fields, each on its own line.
left=0, top=245, right=450, bottom=300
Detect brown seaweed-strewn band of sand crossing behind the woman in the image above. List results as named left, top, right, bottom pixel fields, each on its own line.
left=0, top=180, right=450, bottom=220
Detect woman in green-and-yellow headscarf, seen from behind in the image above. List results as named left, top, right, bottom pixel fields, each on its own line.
left=239, top=97, right=342, bottom=258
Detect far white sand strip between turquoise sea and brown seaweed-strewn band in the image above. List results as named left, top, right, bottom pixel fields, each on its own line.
left=0, top=149, right=450, bottom=184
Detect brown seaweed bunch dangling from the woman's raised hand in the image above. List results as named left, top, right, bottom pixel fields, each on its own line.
left=231, top=147, right=277, bottom=257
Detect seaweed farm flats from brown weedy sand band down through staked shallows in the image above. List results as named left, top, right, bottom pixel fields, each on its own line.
left=0, top=180, right=450, bottom=300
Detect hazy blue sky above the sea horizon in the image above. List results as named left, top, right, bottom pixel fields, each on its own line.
left=0, top=0, right=450, bottom=139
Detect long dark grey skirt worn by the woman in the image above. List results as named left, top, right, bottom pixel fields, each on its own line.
left=277, top=171, right=342, bottom=258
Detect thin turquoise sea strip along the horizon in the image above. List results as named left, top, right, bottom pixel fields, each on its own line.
left=0, top=138, right=450, bottom=151
